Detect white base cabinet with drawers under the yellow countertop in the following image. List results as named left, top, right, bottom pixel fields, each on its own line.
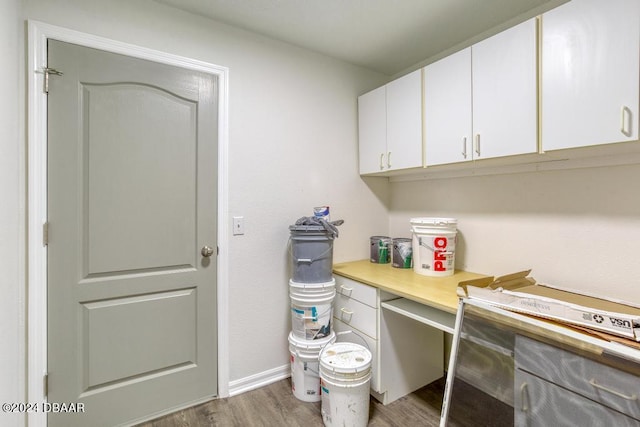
left=333, top=276, right=444, bottom=405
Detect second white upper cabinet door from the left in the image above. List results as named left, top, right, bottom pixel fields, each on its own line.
left=386, top=70, right=422, bottom=170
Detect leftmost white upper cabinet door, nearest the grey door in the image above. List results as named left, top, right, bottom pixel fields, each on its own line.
left=358, top=86, right=387, bottom=175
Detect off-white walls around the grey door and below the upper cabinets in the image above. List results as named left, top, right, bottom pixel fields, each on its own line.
left=6, top=0, right=640, bottom=425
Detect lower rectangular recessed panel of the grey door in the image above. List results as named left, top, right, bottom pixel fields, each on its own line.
left=81, top=289, right=196, bottom=390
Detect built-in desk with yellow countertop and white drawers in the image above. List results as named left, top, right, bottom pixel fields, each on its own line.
left=333, top=259, right=486, bottom=404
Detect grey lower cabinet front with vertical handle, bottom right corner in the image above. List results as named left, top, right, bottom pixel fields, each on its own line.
left=513, top=369, right=638, bottom=427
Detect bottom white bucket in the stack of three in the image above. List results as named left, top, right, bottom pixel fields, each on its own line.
left=289, top=331, right=336, bottom=402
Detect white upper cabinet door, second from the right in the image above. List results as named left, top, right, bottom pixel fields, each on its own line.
left=471, top=19, right=538, bottom=159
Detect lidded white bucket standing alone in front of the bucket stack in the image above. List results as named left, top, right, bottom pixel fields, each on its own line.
left=320, top=342, right=371, bottom=427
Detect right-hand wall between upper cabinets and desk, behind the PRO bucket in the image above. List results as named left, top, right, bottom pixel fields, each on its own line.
left=390, top=165, right=640, bottom=304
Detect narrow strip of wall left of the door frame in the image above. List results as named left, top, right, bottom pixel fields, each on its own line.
left=0, top=0, right=25, bottom=426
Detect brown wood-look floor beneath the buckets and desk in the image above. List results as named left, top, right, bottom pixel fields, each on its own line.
left=136, top=378, right=513, bottom=427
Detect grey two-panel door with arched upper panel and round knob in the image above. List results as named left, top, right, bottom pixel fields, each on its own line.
left=47, top=40, right=217, bottom=426
